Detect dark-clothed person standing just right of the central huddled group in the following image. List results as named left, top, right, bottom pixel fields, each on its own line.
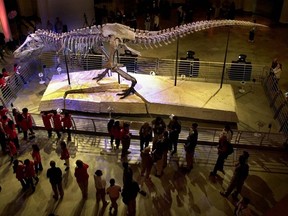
left=184, top=123, right=198, bottom=171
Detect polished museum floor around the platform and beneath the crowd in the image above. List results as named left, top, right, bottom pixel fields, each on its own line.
left=0, top=11, right=288, bottom=216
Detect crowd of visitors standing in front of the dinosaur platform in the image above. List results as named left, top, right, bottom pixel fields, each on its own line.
left=0, top=107, right=249, bottom=215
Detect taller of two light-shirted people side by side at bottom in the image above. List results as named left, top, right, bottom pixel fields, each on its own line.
left=94, top=170, right=108, bottom=206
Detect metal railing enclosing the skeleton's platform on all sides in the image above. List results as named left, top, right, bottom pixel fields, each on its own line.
left=0, top=52, right=288, bottom=147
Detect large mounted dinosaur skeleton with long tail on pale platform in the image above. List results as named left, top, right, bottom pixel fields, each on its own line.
left=14, top=20, right=265, bottom=99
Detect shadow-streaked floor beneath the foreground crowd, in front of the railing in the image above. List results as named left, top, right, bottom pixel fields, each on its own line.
left=0, top=131, right=288, bottom=216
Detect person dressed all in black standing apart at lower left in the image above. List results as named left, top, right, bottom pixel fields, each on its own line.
left=46, top=160, right=64, bottom=200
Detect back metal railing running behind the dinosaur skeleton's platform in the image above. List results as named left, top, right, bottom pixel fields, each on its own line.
left=37, top=52, right=265, bottom=83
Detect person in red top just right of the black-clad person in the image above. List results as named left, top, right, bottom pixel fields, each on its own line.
left=74, top=160, right=89, bottom=199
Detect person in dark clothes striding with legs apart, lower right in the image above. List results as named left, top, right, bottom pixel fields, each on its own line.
left=220, top=155, right=249, bottom=200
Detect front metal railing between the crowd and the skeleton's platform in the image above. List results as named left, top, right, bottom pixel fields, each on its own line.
left=32, top=114, right=286, bottom=149
